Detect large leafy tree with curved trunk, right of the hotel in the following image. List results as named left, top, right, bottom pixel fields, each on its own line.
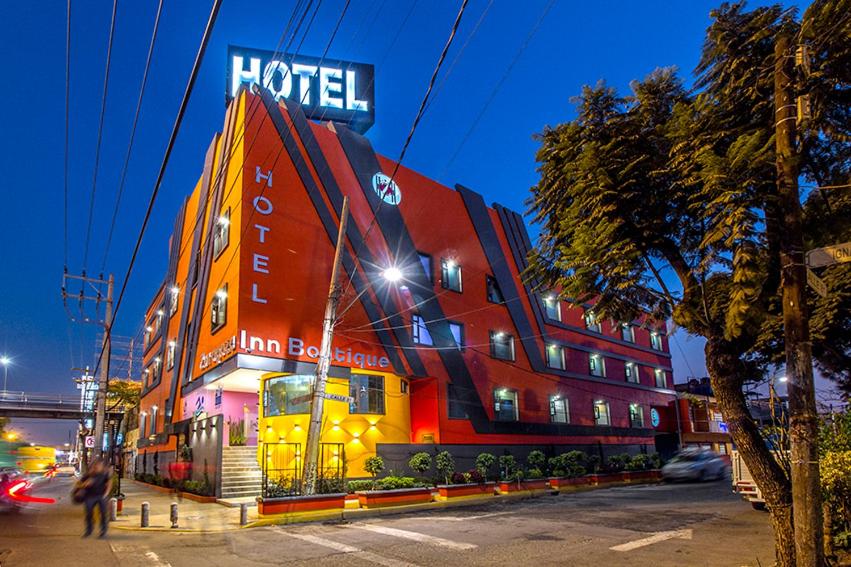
left=526, top=1, right=851, bottom=565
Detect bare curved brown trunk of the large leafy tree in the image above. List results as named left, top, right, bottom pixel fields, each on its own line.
left=705, top=339, right=795, bottom=567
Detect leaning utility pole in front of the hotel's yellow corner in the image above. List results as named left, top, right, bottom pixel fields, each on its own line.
left=302, top=197, right=349, bottom=495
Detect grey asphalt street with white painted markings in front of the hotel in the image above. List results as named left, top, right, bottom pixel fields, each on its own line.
left=0, top=479, right=774, bottom=567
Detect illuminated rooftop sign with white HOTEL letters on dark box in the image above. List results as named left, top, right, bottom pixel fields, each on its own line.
left=227, top=45, right=375, bottom=133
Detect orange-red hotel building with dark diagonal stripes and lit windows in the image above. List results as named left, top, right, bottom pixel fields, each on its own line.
left=137, top=89, right=676, bottom=492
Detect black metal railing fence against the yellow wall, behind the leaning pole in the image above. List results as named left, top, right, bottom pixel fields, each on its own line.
left=262, top=442, right=346, bottom=498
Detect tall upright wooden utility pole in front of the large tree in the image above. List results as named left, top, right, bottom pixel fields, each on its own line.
left=774, top=31, right=824, bottom=567
